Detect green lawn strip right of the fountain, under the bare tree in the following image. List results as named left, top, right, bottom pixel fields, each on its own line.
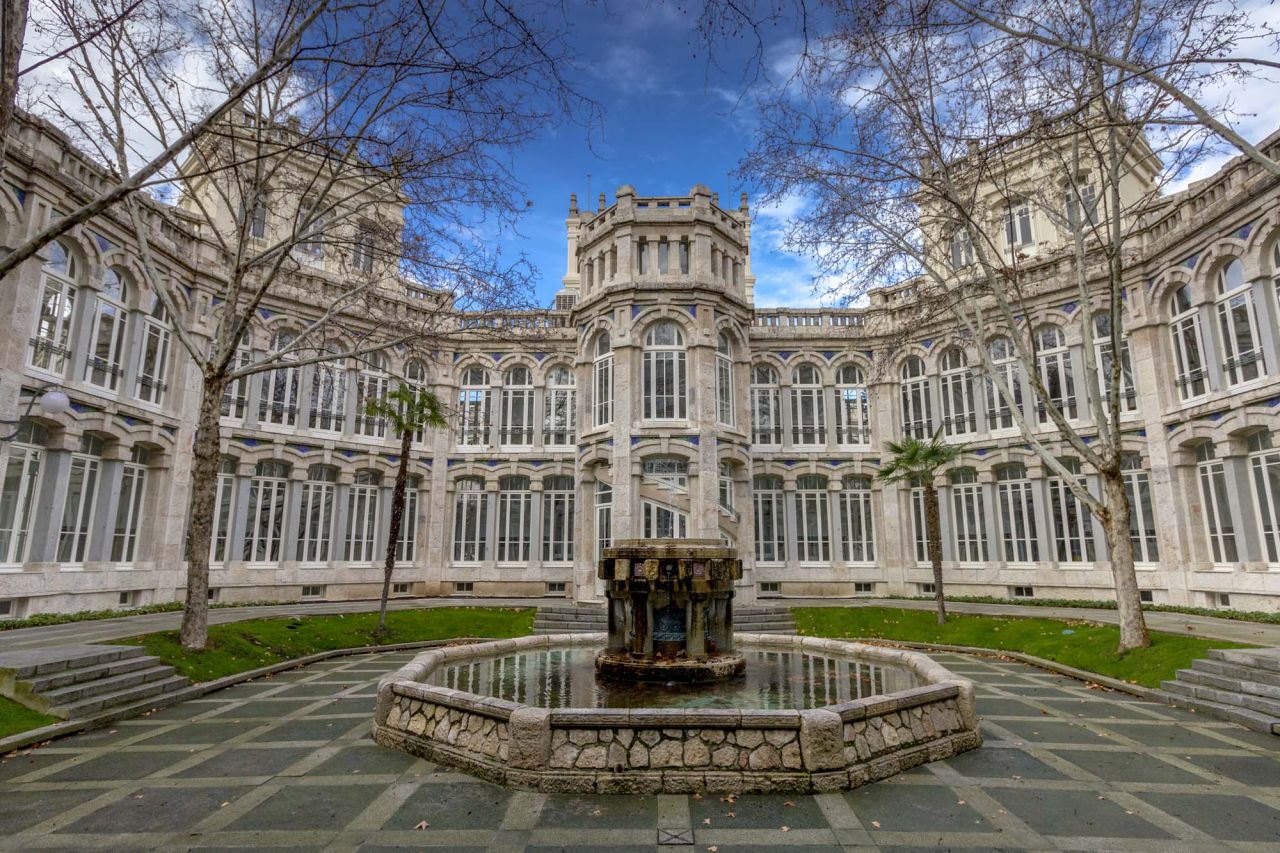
left=791, top=607, right=1244, bottom=686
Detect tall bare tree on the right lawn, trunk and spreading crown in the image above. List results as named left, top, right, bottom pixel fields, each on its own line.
left=744, top=0, right=1264, bottom=651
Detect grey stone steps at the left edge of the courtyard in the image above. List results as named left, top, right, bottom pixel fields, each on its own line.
left=0, top=646, right=191, bottom=720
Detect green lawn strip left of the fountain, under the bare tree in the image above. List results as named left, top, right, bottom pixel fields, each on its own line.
left=120, top=607, right=534, bottom=681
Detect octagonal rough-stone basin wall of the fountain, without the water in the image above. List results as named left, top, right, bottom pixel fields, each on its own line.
left=374, top=634, right=982, bottom=793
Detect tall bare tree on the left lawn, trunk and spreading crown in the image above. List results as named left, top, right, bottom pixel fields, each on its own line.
left=19, top=0, right=590, bottom=649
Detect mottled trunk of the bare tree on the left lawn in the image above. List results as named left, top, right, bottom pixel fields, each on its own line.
left=182, top=375, right=232, bottom=652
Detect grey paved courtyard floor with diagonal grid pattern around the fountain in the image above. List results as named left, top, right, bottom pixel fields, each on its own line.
left=0, top=653, right=1280, bottom=853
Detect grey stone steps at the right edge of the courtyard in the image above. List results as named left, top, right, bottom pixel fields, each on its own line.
left=1161, top=648, right=1280, bottom=735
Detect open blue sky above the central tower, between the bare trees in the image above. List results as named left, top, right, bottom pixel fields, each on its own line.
left=500, top=3, right=815, bottom=306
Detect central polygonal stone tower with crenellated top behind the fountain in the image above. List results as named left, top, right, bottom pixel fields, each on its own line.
left=556, top=184, right=755, bottom=601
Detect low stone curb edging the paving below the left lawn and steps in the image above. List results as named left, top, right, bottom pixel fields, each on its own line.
left=0, top=637, right=490, bottom=756
